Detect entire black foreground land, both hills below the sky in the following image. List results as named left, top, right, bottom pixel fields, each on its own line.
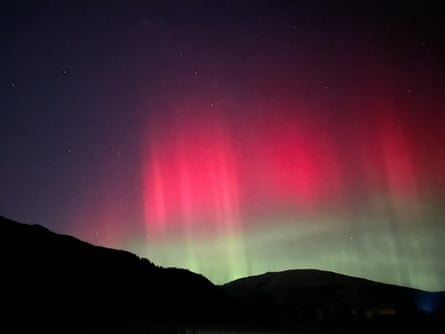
left=0, top=217, right=445, bottom=333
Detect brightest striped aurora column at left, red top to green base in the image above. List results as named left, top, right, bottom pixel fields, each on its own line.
left=144, top=108, right=246, bottom=277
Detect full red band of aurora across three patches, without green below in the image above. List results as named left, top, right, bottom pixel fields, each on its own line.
left=144, top=92, right=434, bottom=235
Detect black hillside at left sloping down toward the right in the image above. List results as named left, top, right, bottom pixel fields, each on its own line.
left=0, top=217, right=243, bottom=322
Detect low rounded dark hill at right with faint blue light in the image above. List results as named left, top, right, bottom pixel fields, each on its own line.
left=223, top=270, right=445, bottom=322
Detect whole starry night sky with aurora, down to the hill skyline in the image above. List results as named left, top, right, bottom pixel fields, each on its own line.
left=0, top=0, right=445, bottom=290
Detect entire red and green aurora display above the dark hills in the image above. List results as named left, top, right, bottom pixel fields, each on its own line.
left=136, top=90, right=443, bottom=289
